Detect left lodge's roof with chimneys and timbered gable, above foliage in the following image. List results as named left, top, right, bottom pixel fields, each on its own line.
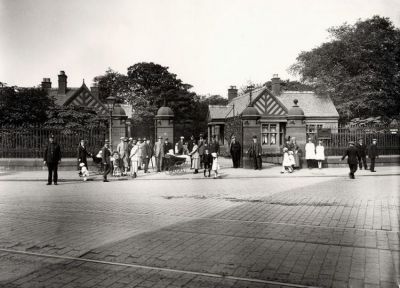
left=42, top=71, right=109, bottom=117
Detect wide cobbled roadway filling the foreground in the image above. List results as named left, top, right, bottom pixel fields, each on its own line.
left=0, top=169, right=400, bottom=287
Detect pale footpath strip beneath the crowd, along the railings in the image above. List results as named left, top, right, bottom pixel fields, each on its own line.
left=0, top=158, right=400, bottom=182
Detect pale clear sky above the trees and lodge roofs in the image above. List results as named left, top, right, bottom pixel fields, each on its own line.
left=0, top=0, right=400, bottom=97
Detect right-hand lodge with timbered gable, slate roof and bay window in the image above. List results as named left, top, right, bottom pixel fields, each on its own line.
left=208, top=75, right=339, bottom=152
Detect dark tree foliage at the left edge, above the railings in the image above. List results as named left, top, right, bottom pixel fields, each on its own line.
left=0, top=87, right=54, bottom=126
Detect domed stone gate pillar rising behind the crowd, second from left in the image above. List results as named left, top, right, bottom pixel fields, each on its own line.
left=154, top=106, right=175, bottom=145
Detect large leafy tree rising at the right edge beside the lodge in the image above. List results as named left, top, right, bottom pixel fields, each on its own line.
left=290, top=16, right=400, bottom=121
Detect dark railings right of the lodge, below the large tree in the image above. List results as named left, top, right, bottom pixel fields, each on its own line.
left=323, top=127, right=400, bottom=156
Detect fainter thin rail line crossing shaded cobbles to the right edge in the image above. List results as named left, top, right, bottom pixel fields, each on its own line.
left=165, top=229, right=400, bottom=252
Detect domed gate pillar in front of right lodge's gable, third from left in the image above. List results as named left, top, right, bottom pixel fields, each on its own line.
left=242, top=106, right=261, bottom=168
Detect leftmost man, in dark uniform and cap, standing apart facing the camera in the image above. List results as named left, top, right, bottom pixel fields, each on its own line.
left=43, top=134, right=61, bottom=185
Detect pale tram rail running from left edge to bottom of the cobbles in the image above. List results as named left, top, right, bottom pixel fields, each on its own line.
left=0, top=248, right=318, bottom=288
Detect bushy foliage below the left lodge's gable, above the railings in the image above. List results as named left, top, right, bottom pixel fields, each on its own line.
left=44, top=106, right=105, bottom=130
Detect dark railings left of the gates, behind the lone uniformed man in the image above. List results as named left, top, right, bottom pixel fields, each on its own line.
left=0, top=127, right=107, bottom=158
